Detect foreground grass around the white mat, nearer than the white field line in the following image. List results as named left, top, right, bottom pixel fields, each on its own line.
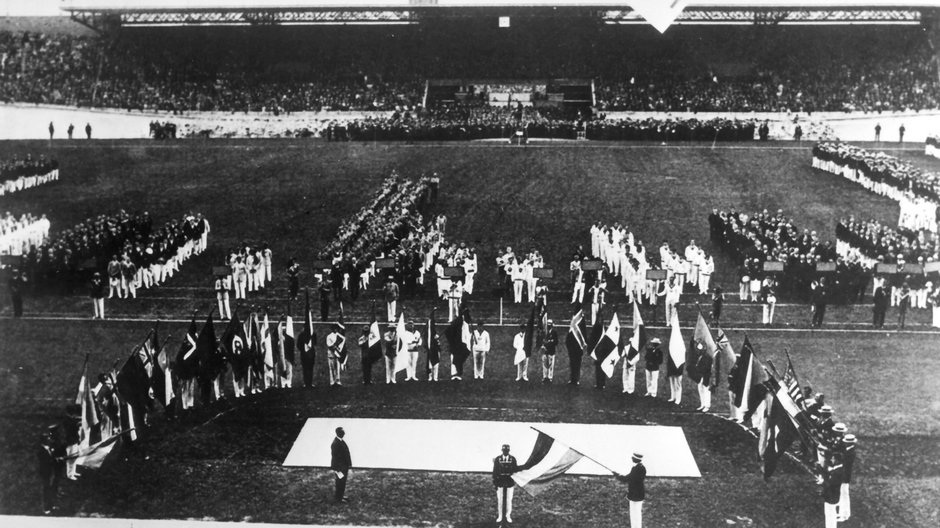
left=0, top=320, right=940, bottom=526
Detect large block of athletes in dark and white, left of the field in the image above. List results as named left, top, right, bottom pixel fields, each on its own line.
left=12, top=210, right=209, bottom=298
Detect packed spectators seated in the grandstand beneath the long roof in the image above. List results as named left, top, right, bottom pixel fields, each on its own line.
left=0, top=22, right=940, bottom=113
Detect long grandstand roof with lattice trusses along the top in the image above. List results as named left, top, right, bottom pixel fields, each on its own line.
left=62, top=0, right=938, bottom=32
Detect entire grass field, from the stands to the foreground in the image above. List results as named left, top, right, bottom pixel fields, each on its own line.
left=0, top=141, right=940, bottom=527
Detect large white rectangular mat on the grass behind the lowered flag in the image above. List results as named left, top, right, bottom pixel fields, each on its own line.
left=284, top=418, right=702, bottom=477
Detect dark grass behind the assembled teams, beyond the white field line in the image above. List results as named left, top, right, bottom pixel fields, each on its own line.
left=0, top=140, right=928, bottom=325
